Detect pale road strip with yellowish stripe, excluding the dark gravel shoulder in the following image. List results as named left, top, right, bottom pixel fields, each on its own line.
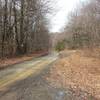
left=0, top=55, right=58, bottom=90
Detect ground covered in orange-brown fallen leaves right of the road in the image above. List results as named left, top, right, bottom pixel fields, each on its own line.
left=47, top=51, right=100, bottom=98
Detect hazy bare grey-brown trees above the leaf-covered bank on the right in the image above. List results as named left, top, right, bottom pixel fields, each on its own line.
left=65, top=0, right=100, bottom=48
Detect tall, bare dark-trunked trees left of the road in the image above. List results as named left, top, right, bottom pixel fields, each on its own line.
left=0, top=0, right=49, bottom=57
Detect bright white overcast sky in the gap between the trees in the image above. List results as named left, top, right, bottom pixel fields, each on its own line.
left=50, top=0, right=85, bottom=32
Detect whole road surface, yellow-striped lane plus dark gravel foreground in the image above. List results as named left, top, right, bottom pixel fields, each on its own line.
left=0, top=54, right=96, bottom=100
